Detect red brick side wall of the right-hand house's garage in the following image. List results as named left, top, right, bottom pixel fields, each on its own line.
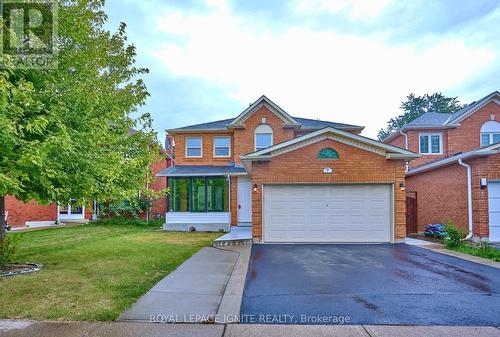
left=406, top=164, right=468, bottom=232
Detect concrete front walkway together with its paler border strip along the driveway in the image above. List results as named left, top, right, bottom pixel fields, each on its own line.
left=119, top=245, right=251, bottom=323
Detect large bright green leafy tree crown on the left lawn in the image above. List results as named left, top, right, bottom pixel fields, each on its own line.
left=0, top=0, right=160, bottom=239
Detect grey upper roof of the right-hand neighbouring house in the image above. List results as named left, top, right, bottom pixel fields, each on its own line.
left=384, top=91, right=500, bottom=142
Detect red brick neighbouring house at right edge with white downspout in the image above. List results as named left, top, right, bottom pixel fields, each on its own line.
left=384, top=91, right=500, bottom=241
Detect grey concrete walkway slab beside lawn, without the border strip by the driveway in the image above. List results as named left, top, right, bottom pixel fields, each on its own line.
left=119, top=247, right=239, bottom=323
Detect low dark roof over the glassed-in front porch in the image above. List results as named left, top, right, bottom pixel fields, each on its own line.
left=156, top=165, right=247, bottom=177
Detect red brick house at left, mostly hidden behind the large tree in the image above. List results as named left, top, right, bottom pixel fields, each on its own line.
left=5, top=143, right=172, bottom=227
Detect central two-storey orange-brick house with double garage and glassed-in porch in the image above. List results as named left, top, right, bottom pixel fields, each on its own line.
left=159, top=96, right=419, bottom=242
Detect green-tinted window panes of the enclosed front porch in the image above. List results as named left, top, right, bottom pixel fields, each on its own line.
left=168, top=177, right=229, bottom=212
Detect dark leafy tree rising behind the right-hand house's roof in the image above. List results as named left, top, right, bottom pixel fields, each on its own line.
left=378, top=93, right=464, bottom=140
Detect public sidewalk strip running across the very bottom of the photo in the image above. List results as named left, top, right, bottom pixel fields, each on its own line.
left=0, top=320, right=500, bottom=337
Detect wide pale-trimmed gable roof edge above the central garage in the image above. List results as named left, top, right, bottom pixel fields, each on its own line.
left=240, top=127, right=420, bottom=161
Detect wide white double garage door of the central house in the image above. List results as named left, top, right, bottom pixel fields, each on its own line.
left=264, top=185, right=392, bottom=242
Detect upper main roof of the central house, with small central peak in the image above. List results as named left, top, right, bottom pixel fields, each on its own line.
left=167, top=96, right=364, bottom=133
